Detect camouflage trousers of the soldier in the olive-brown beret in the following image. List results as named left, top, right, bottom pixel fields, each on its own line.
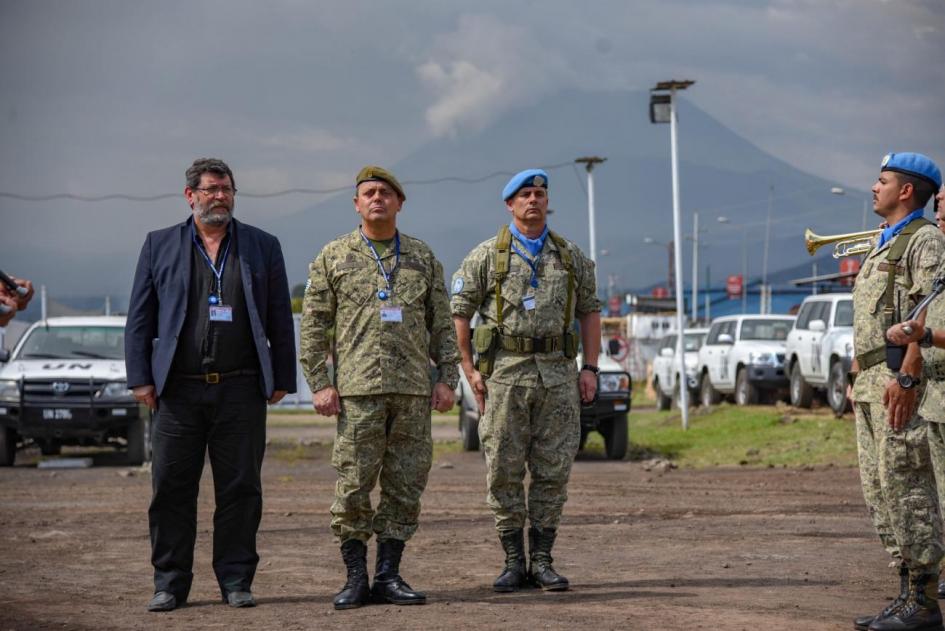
left=331, top=394, right=433, bottom=543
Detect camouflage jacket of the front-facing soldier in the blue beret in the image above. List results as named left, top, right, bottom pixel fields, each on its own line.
left=450, top=230, right=601, bottom=386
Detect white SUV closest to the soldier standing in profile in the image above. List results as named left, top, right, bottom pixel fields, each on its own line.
left=786, top=293, right=853, bottom=416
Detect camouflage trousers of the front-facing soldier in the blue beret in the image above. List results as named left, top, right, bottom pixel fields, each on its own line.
left=479, top=382, right=581, bottom=531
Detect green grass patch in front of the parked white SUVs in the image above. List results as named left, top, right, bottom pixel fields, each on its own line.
left=616, top=404, right=857, bottom=467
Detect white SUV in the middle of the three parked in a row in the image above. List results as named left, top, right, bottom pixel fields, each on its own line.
left=698, top=315, right=794, bottom=406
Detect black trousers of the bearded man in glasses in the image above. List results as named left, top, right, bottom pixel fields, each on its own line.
left=148, top=376, right=266, bottom=602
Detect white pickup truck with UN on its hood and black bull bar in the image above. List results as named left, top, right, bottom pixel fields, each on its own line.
left=0, top=316, right=150, bottom=467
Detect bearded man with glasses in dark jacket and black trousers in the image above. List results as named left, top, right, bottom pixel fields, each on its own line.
left=125, top=158, right=296, bottom=611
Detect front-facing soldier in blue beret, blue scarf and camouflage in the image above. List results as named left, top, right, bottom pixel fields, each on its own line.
left=451, top=169, right=600, bottom=592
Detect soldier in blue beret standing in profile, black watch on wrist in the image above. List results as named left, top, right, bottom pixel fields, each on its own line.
left=852, top=153, right=945, bottom=631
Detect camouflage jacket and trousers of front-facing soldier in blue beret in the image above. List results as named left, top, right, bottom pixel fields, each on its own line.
left=451, top=230, right=600, bottom=533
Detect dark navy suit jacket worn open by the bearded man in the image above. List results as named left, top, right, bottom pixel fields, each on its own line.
left=125, top=217, right=296, bottom=399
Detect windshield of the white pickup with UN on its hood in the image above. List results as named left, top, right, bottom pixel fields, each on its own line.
left=16, top=326, right=125, bottom=359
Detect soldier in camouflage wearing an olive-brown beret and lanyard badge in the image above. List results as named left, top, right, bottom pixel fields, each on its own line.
left=300, top=166, right=459, bottom=609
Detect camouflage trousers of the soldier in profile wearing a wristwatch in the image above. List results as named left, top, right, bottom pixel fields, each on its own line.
left=854, top=402, right=945, bottom=574
